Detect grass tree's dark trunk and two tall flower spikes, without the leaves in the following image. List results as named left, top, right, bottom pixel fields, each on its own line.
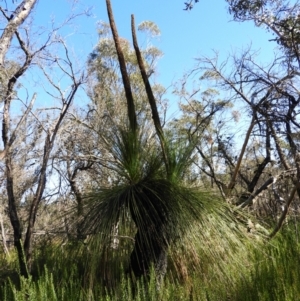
left=106, top=0, right=169, bottom=278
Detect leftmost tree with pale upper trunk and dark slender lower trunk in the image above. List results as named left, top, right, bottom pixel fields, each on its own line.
left=0, top=0, right=43, bottom=275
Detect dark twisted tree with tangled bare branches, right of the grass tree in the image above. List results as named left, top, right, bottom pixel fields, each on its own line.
left=193, top=42, right=300, bottom=234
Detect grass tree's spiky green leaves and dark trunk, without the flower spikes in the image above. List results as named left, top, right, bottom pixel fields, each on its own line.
left=76, top=115, right=244, bottom=277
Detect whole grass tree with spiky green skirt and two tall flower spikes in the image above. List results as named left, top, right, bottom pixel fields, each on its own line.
left=78, top=0, right=248, bottom=286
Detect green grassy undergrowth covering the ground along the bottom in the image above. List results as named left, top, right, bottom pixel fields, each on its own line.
left=0, top=223, right=300, bottom=301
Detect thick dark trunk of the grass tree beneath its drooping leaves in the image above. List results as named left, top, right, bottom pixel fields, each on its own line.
left=130, top=185, right=169, bottom=285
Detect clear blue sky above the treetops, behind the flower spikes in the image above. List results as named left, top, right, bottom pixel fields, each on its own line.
left=27, top=0, right=275, bottom=114
